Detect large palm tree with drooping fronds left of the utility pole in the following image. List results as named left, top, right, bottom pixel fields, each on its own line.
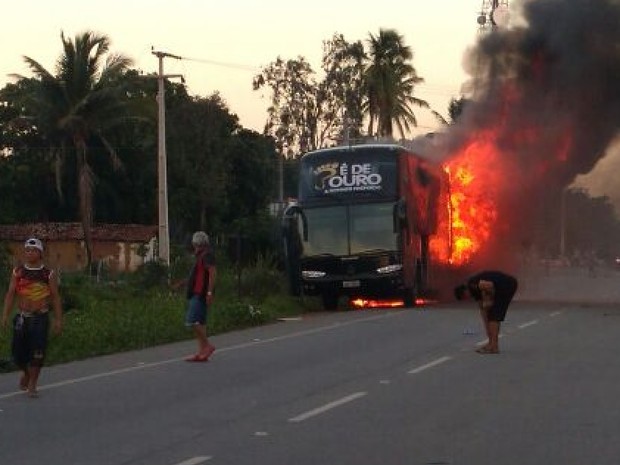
left=18, top=31, right=132, bottom=269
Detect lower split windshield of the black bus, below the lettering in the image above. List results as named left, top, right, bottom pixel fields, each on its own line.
left=300, top=202, right=397, bottom=256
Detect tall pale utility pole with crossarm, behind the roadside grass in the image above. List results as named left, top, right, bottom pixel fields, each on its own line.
left=152, top=50, right=183, bottom=266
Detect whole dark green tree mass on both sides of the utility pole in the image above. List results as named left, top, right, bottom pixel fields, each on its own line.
left=0, top=70, right=276, bottom=260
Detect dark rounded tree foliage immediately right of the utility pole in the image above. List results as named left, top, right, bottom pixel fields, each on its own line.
left=167, top=92, right=277, bottom=246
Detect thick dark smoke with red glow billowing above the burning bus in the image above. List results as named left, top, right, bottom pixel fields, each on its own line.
left=434, top=0, right=620, bottom=268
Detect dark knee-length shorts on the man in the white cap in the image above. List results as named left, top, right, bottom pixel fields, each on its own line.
left=11, top=312, right=49, bottom=368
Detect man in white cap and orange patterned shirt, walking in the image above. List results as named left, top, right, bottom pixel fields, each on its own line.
left=2, top=237, right=62, bottom=397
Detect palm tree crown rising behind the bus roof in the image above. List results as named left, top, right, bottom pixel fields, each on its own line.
left=364, top=29, right=429, bottom=138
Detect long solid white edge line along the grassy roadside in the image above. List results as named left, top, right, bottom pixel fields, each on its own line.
left=0, top=312, right=398, bottom=400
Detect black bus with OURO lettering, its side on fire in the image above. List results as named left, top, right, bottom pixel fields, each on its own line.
left=283, top=144, right=443, bottom=310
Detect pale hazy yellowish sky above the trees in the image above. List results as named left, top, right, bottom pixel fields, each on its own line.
left=0, top=0, right=482, bottom=132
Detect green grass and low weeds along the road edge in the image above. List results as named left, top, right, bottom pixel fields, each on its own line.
left=0, top=256, right=319, bottom=371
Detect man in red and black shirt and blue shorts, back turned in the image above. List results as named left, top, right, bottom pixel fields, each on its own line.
left=185, top=231, right=216, bottom=362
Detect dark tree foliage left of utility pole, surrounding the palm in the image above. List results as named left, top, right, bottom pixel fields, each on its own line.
left=0, top=70, right=157, bottom=224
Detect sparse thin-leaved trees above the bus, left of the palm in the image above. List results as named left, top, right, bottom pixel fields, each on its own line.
left=253, top=34, right=364, bottom=156
